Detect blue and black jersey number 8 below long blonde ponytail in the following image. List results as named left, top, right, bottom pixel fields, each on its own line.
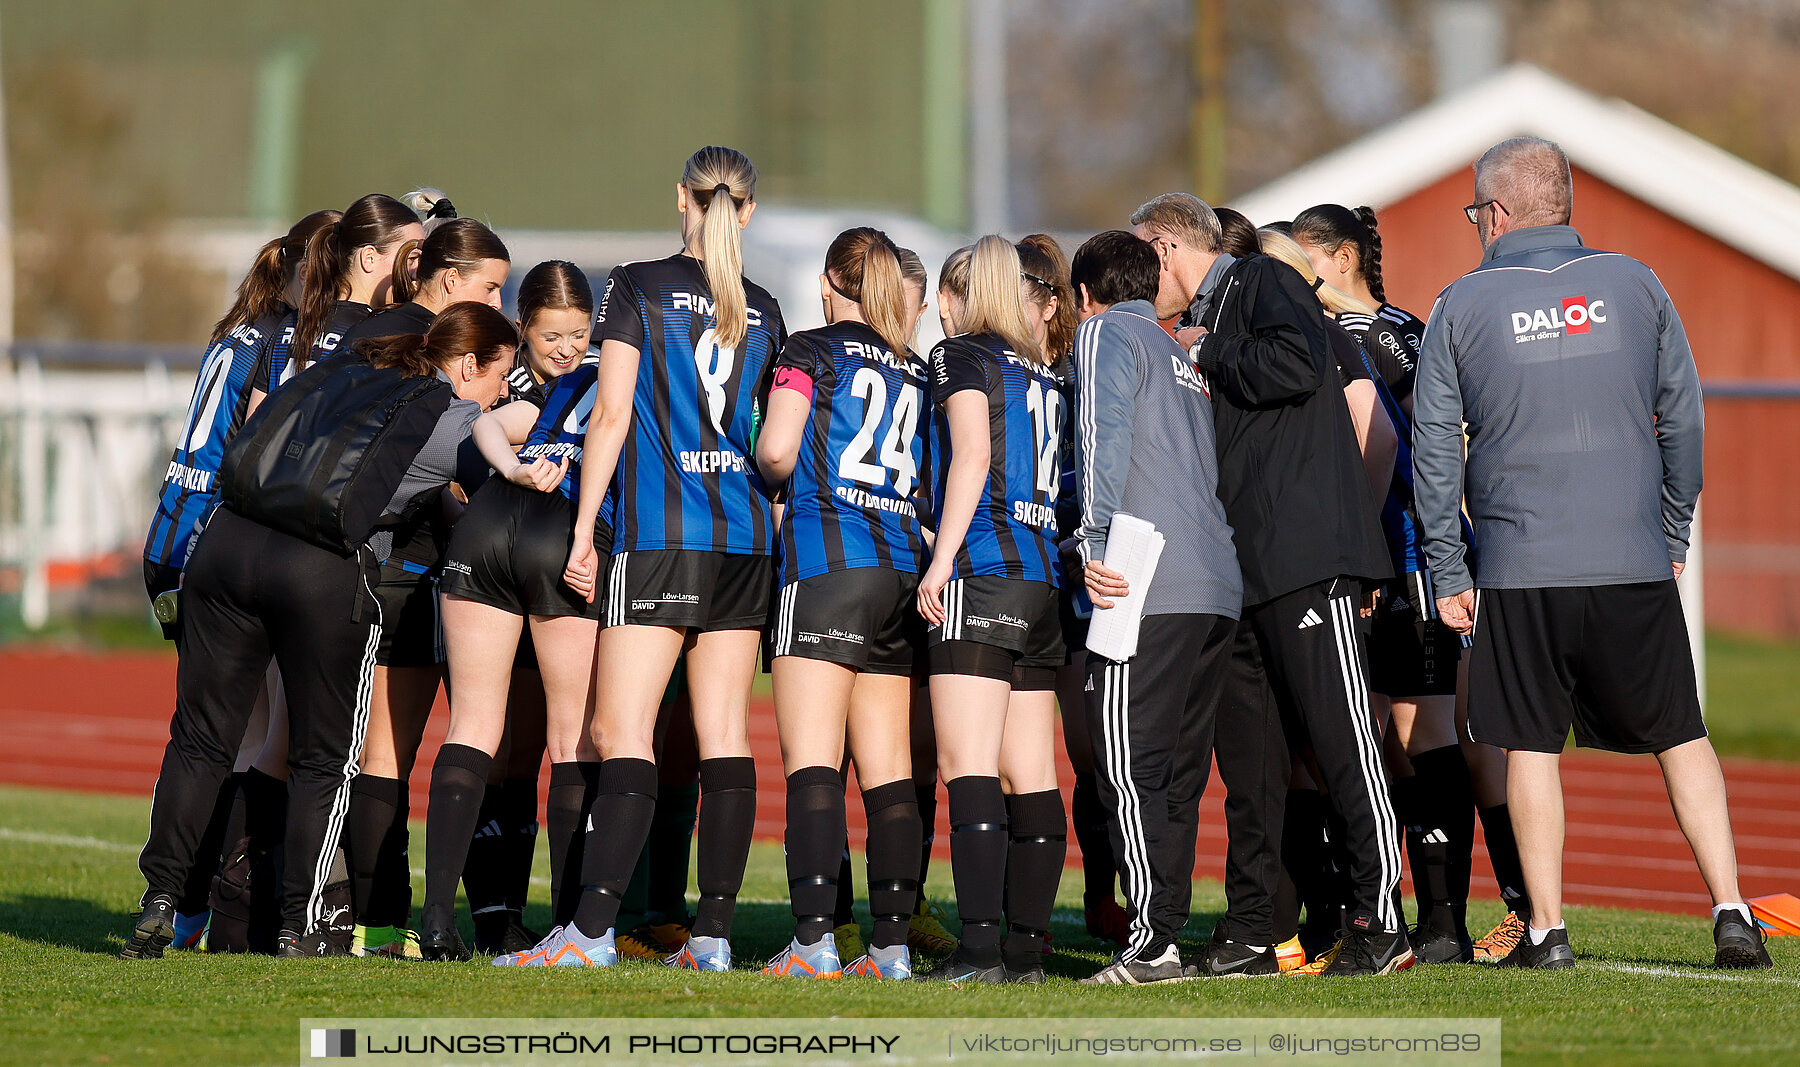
left=596, top=254, right=787, bottom=556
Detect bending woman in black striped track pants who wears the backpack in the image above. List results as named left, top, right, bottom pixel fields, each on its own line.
left=122, top=304, right=518, bottom=959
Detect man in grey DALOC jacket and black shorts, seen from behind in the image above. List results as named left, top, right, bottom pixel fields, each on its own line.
left=1413, top=139, right=1769, bottom=968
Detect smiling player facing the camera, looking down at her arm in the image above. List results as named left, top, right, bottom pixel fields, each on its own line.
left=406, top=263, right=598, bottom=959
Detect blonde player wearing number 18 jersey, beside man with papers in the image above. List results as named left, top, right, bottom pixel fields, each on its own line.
left=918, top=236, right=1066, bottom=982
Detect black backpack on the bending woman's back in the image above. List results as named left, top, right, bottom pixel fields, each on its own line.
left=220, top=356, right=455, bottom=556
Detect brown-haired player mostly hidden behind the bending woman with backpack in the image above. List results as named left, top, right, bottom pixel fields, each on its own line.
left=340, top=220, right=511, bottom=952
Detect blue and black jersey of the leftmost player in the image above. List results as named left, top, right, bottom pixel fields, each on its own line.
left=144, top=308, right=288, bottom=569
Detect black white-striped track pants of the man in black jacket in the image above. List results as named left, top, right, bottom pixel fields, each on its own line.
left=1213, top=578, right=1404, bottom=945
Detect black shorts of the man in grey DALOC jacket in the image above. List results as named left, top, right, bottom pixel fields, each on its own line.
left=1469, top=578, right=1706, bottom=752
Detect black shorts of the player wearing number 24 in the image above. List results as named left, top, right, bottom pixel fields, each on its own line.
left=769, top=567, right=925, bottom=675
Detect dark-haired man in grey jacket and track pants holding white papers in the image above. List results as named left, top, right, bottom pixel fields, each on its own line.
left=1069, top=230, right=1244, bottom=984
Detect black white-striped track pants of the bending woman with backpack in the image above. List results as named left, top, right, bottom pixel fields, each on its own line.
left=139, top=509, right=380, bottom=932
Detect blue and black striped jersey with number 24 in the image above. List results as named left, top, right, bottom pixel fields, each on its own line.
left=776, top=322, right=931, bottom=585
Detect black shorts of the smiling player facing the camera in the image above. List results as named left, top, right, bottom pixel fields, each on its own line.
left=437, top=479, right=599, bottom=619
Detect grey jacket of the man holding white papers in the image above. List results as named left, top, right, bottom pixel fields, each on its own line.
left=1075, top=300, right=1244, bottom=619
